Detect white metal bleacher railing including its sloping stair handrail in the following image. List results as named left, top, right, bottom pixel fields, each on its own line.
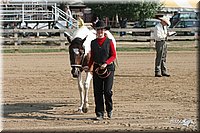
left=0, top=2, right=78, bottom=28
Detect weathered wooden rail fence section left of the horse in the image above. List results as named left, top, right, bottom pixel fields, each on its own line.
left=1, top=29, right=76, bottom=50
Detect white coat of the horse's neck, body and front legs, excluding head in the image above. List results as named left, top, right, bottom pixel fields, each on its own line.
left=72, top=26, right=116, bottom=112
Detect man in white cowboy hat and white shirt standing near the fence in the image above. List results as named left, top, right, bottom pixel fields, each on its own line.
left=154, top=16, right=170, bottom=77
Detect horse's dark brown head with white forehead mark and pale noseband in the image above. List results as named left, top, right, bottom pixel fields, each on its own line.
left=69, top=37, right=86, bottom=78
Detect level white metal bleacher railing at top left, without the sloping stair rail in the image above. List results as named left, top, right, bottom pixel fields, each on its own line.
left=0, top=4, right=54, bottom=22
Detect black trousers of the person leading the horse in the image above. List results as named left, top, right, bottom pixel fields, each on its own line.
left=93, top=71, right=114, bottom=117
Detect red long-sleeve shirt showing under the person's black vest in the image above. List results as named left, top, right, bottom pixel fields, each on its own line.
left=89, top=36, right=116, bottom=68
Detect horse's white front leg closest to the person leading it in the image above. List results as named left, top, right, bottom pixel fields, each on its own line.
left=83, top=72, right=92, bottom=113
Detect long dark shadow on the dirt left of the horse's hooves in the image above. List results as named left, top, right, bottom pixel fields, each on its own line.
left=2, top=103, right=93, bottom=120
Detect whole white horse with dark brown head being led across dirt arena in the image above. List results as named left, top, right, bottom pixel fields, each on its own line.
left=67, top=26, right=116, bottom=113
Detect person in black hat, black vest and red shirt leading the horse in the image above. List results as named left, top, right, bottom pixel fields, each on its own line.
left=89, top=20, right=116, bottom=120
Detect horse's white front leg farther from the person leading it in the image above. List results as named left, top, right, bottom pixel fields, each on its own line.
left=77, top=72, right=84, bottom=113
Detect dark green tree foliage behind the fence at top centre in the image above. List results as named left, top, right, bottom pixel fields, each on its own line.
left=86, top=1, right=162, bottom=21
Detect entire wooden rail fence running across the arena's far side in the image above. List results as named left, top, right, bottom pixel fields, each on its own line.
left=1, top=28, right=199, bottom=49
